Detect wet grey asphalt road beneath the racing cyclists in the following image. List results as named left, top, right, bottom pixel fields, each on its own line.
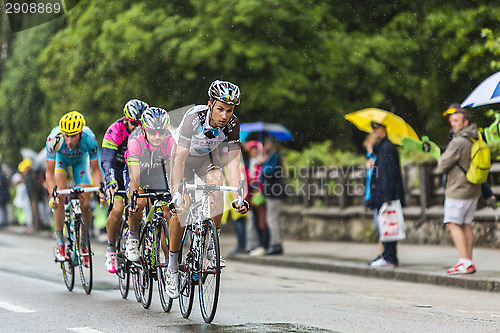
left=0, top=232, right=500, bottom=332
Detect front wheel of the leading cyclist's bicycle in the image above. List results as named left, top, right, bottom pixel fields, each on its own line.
left=198, top=219, right=221, bottom=323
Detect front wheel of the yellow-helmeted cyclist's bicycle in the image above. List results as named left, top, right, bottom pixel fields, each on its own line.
left=75, top=218, right=93, bottom=294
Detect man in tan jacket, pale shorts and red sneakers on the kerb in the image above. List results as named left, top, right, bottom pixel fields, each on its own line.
left=438, top=108, right=481, bottom=275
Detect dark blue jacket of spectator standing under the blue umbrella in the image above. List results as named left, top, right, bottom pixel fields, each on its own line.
left=260, top=151, right=286, bottom=199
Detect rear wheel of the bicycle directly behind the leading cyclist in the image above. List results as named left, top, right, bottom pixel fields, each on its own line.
left=138, top=223, right=156, bottom=309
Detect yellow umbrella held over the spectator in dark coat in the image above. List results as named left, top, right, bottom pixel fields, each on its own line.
left=345, top=108, right=420, bottom=145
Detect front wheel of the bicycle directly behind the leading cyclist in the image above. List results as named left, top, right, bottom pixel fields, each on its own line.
left=155, top=220, right=173, bottom=312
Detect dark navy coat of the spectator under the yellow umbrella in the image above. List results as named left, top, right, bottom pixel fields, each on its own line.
left=366, top=137, right=406, bottom=209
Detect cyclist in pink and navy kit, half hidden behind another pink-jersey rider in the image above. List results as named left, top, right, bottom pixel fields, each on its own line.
left=101, top=99, right=149, bottom=273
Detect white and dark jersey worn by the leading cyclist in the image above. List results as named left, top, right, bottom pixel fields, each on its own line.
left=174, top=105, right=240, bottom=156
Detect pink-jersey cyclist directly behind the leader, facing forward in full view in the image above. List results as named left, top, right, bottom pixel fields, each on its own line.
left=125, top=107, right=180, bottom=296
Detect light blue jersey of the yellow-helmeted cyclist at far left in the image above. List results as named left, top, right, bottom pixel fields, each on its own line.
left=45, top=126, right=99, bottom=162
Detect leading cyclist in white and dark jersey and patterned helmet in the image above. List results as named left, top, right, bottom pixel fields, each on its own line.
left=169, top=80, right=249, bottom=282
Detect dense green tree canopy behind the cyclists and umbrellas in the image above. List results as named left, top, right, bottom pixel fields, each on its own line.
left=0, top=0, right=500, bottom=165
